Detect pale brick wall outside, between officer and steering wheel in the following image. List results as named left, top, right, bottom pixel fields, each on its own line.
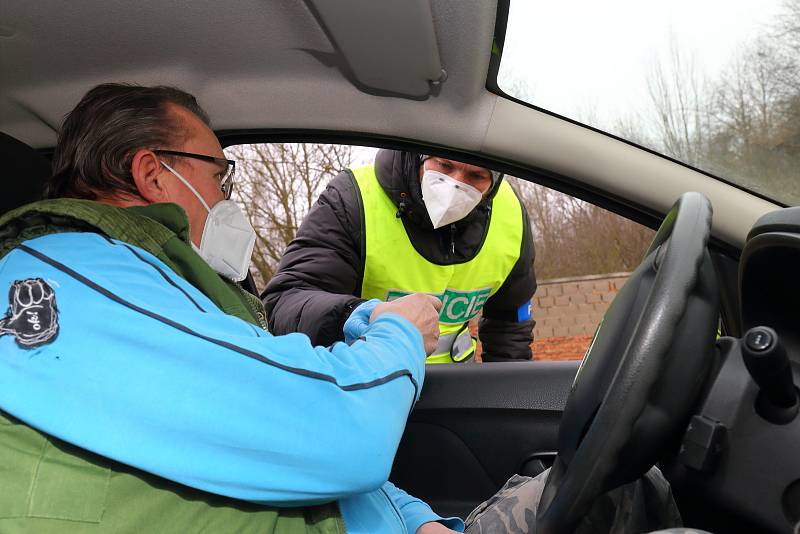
left=533, top=273, right=630, bottom=340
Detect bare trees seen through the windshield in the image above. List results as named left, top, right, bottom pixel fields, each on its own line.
left=648, top=0, right=800, bottom=203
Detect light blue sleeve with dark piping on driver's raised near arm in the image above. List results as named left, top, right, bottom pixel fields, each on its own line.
left=0, top=234, right=425, bottom=506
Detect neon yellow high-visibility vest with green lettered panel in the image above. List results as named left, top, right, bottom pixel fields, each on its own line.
left=353, top=166, right=523, bottom=363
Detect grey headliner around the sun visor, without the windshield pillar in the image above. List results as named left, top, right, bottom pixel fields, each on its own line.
left=0, top=0, right=495, bottom=149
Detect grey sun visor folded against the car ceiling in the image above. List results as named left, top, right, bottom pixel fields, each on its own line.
left=306, top=0, right=446, bottom=100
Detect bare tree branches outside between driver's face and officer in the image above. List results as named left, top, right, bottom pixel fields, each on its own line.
left=227, top=143, right=352, bottom=287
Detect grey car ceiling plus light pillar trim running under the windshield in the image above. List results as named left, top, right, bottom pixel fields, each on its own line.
left=0, top=0, right=777, bottom=247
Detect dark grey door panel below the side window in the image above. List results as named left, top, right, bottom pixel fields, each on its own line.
left=391, top=361, right=580, bottom=517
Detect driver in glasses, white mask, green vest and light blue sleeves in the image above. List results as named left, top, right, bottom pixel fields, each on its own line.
left=0, top=84, right=463, bottom=534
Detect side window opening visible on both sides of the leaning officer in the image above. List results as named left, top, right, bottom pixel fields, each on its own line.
left=225, top=143, right=654, bottom=360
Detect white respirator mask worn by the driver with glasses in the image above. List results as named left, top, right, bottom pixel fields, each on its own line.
left=161, top=161, right=256, bottom=282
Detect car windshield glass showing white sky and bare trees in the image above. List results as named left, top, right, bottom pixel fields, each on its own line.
left=497, top=0, right=800, bottom=205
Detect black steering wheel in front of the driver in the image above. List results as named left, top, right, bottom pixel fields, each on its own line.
left=536, top=193, right=719, bottom=534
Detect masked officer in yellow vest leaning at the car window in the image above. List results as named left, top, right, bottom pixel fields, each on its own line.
left=262, top=150, right=536, bottom=363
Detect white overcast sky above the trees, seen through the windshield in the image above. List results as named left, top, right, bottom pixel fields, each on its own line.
left=500, top=0, right=782, bottom=131
